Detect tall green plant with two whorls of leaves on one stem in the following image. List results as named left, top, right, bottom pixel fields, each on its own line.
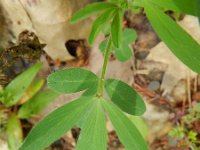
left=20, top=0, right=200, bottom=150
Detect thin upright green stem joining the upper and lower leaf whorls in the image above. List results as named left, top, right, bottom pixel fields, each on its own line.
left=97, top=35, right=112, bottom=97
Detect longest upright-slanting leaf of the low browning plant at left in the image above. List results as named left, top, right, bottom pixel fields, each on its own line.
left=3, top=64, right=41, bottom=107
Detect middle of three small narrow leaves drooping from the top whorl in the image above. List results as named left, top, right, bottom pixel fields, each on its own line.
left=88, top=9, right=116, bottom=44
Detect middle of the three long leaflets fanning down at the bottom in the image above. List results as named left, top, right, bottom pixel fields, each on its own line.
left=76, top=98, right=107, bottom=150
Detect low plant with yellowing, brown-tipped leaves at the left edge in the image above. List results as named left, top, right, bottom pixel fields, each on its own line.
left=0, top=64, right=58, bottom=150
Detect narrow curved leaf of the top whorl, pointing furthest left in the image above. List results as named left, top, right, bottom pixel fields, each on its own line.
left=71, top=2, right=117, bottom=23
